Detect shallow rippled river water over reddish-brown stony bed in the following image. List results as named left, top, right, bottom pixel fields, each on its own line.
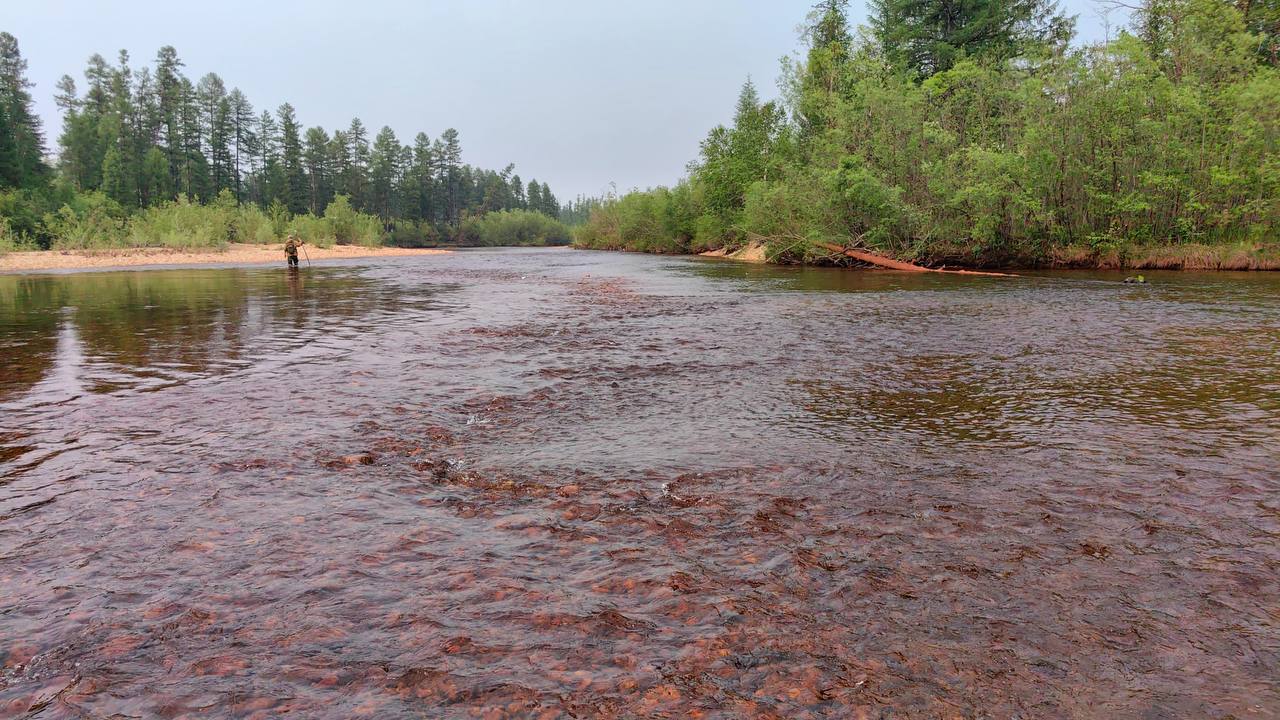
left=0, top=250, right=1280, bottom=719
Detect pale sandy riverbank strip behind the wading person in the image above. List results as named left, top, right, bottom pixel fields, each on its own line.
left=0, top=243, right=449, bottom=273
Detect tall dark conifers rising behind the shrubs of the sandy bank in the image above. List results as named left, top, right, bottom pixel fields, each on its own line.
left=0, top=33, right=561, bottom=251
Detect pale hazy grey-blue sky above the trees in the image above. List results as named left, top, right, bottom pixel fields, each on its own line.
left=10, top=0, right=1124, bottom=200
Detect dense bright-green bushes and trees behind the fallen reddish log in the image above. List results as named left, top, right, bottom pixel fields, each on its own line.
left=576, top=0, right=1280, bottom=266
